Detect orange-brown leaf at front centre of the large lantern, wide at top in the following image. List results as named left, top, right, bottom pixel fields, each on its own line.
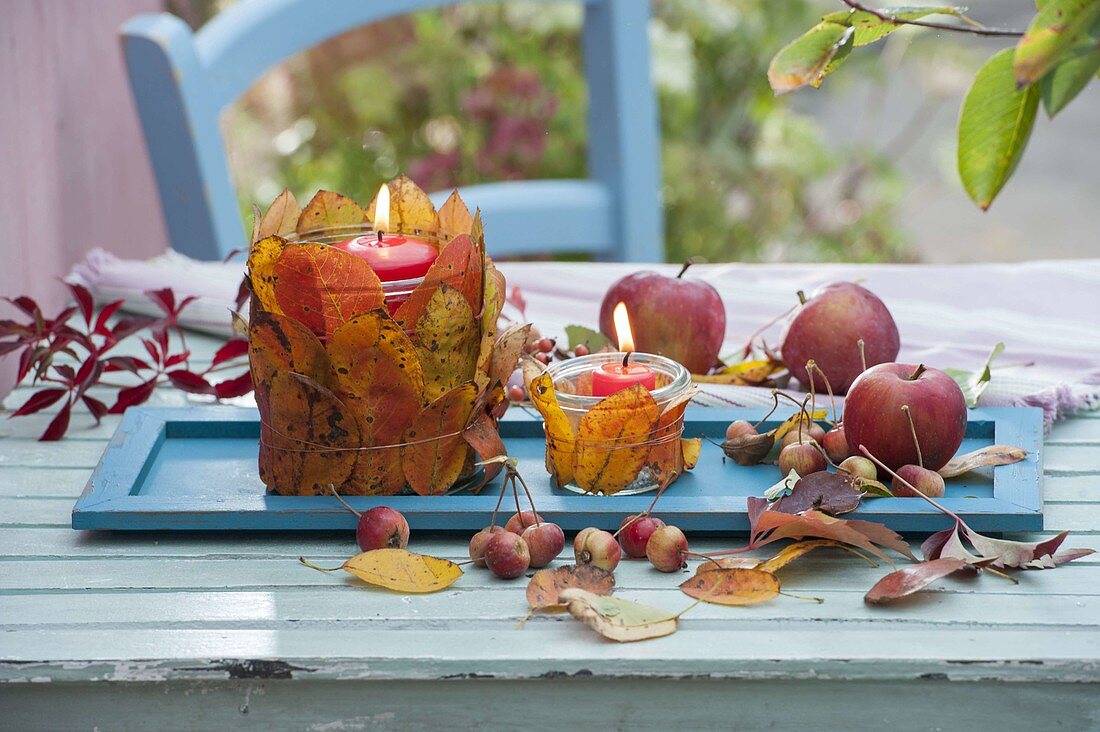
left=328, top=309, right=424, bottom=495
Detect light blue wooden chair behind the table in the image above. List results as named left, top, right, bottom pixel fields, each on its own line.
left=122, top=0, right=663, bottom=261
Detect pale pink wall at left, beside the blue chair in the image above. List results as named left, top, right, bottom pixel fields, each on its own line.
left=0, top=0, right=167, bottom=395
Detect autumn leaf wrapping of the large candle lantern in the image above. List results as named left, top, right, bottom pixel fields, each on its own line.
left=248, top=178, right=527, bottom=495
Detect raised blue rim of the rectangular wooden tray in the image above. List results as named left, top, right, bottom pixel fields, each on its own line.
left=72, top=405, right=1043, bottom=533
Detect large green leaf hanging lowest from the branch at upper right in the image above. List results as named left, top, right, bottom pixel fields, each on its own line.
left=958, top=48, right=1040, bottom=210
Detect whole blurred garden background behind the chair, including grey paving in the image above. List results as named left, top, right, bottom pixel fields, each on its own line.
left=168, top=0, right=1100, bottom=262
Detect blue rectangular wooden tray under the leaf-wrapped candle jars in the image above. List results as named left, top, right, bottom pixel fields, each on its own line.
left=73, top=406, right=1043, bottom=533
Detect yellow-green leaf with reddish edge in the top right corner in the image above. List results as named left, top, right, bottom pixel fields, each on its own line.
left=1013, top=0, right=1100, bottom=87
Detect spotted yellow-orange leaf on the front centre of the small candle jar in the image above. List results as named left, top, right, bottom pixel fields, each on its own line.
left=573, top=384, right=659, bottom=495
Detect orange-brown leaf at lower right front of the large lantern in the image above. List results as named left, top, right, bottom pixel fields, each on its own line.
left=402, top=382, right=477, bottom=495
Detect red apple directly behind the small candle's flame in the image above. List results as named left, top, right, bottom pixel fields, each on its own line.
left=600, top=263, right=726, bottom=373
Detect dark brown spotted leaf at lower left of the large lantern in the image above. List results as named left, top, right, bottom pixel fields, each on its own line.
left=256, top=371, right=362, bottom=495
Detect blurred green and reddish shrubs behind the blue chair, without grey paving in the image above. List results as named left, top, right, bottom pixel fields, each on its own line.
left=184, top=0, right=906, bottom=261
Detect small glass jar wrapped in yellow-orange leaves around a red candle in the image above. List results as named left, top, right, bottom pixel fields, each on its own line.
left=527, top=353, right=701, bottom=495
